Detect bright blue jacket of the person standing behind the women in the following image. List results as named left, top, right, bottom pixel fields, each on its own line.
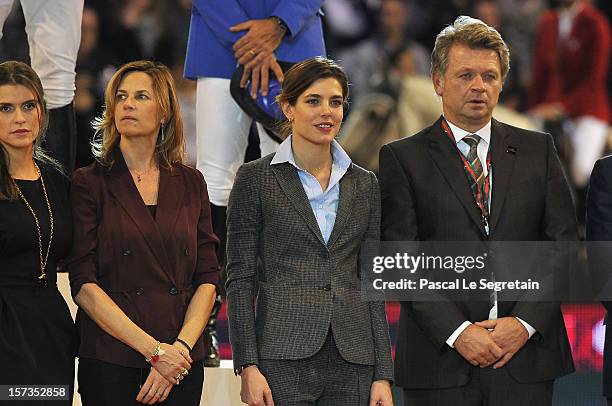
left=185, top=0, right=325, bottom=79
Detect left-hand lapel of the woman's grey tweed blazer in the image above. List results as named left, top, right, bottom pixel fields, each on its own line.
left=271, top=163, right=325, bottom=245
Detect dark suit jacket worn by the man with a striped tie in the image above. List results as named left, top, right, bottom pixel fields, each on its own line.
left=380, top=119, right=578, bottom=389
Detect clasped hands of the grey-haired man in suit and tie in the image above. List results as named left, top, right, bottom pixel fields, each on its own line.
left=455, top=317, right=529, bottom=368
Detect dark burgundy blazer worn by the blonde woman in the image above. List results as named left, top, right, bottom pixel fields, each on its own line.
left=68, top=148, right=219, bottom=368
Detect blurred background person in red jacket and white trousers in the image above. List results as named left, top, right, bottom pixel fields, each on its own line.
left=529, top=0, right=610, bottom=192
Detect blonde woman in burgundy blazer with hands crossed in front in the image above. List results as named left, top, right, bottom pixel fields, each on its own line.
left=68, top=61, right=218, bottom=405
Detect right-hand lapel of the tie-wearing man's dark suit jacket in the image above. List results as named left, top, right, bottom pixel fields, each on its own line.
left=490, top=120, right=519, bottom=234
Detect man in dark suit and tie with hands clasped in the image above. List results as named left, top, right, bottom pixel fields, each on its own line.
left=380, top=16, right=577, bottom=406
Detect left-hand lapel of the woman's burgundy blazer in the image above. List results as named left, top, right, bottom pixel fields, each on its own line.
left=107, top=152, right=173, bottom=281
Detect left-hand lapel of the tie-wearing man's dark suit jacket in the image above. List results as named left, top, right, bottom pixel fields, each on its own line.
left=428, top=119, right=486, bottom=235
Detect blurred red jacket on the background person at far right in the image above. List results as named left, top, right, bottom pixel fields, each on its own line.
left=529, top=4, right=611, bottom=122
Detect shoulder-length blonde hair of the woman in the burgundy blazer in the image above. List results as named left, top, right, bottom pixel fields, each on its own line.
left=91, top=61, right=185, bottom=169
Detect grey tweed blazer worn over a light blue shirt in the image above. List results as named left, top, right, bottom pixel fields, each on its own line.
left=226, top=155, right=393, bottom=380
